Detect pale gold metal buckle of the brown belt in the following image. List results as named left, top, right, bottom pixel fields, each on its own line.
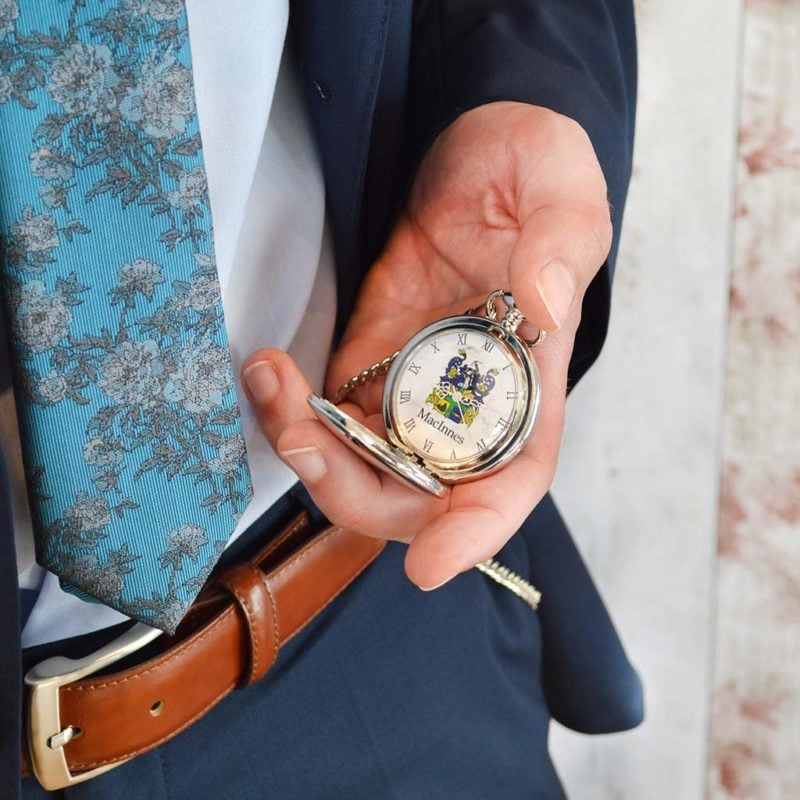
left=25, top=622, right=162, bottom=791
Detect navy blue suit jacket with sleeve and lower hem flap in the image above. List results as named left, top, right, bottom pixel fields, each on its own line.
left=0, top=0, right=642, bottom=797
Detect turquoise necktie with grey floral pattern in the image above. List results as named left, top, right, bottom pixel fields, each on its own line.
left=0, top=0, right=251, bottom=632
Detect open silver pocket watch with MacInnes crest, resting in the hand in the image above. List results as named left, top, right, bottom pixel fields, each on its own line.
left=308, top=290, right=544, bottom=497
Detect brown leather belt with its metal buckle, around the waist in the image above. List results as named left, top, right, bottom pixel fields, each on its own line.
left=23, top=514, right=384, bottom=790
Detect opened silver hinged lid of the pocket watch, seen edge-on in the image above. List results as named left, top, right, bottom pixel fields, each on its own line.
left=308, top=394, right=447, bottom=497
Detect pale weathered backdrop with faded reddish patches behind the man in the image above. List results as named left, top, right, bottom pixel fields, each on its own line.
left=552, top=0, right=800, bottom=800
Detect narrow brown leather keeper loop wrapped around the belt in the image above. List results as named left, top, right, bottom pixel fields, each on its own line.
left=219, top=562, right=280, bottom=689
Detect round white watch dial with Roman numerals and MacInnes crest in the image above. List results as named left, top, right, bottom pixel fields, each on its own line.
left=385, top=318, right=538, bottom=474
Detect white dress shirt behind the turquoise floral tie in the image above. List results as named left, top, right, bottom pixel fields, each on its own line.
left=0, top=0, right=336, bottom=647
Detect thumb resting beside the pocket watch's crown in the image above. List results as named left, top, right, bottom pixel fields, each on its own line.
left=509, top=202, right=612, bottom=331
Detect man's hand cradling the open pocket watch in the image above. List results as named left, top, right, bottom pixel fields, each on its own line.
left=242, top=102, right=611, bottom=589
